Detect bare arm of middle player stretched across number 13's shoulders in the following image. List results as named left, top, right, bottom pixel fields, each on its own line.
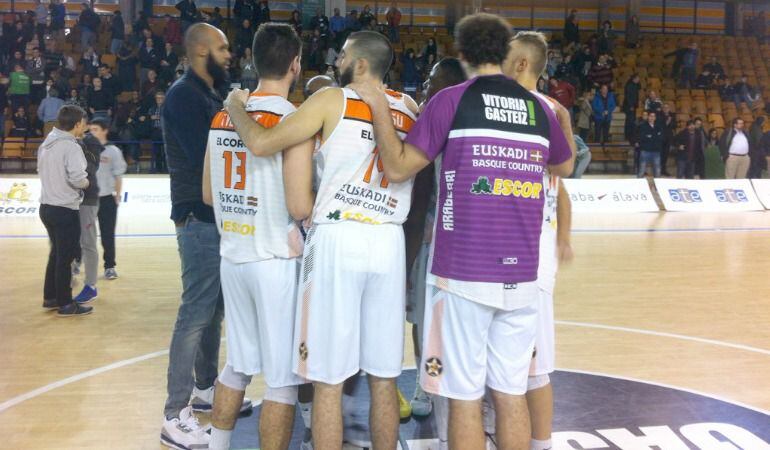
left=224, top=89, right=343, bottom=156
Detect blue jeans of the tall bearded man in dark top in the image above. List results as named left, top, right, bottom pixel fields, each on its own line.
left=164, top=217, right=224, bottom=417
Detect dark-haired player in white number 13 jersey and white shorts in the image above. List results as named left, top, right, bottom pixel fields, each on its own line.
left=203, top=23, right=313, bottom=450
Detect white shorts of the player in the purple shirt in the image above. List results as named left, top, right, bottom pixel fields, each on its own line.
left=420, top=286, right=537, bottom=400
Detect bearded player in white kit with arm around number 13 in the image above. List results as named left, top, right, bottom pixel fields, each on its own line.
left=220, top=31, right=417, bottom=450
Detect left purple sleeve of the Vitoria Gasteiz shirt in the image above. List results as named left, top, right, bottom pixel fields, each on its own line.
left=405, top=89, right=457, bottom=161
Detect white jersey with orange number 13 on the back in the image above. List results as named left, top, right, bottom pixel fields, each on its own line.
left=208, top=93, right=302, bottom=264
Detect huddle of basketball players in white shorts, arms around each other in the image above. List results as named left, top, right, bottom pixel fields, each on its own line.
left=196, top=14, right=574, bottom=450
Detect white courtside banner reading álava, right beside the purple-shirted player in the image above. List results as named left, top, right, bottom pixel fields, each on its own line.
left=562, top=178, right=660, bottom=213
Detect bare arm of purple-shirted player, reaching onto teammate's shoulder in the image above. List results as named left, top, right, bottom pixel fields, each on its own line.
left=349, top=83, right=430, bottom=183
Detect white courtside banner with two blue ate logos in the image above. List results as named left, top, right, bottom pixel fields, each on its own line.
left=655, top=178, right=764, bottom=212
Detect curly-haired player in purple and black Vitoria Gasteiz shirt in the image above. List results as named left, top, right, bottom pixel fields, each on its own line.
left=355, top=13, right=574, bottom=450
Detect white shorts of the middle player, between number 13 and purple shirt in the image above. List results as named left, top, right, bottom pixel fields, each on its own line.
left=292, top=221, right=406, bottom=384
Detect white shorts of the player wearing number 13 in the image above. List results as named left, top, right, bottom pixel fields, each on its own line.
left=220, top=258, right=304, bottom=388
